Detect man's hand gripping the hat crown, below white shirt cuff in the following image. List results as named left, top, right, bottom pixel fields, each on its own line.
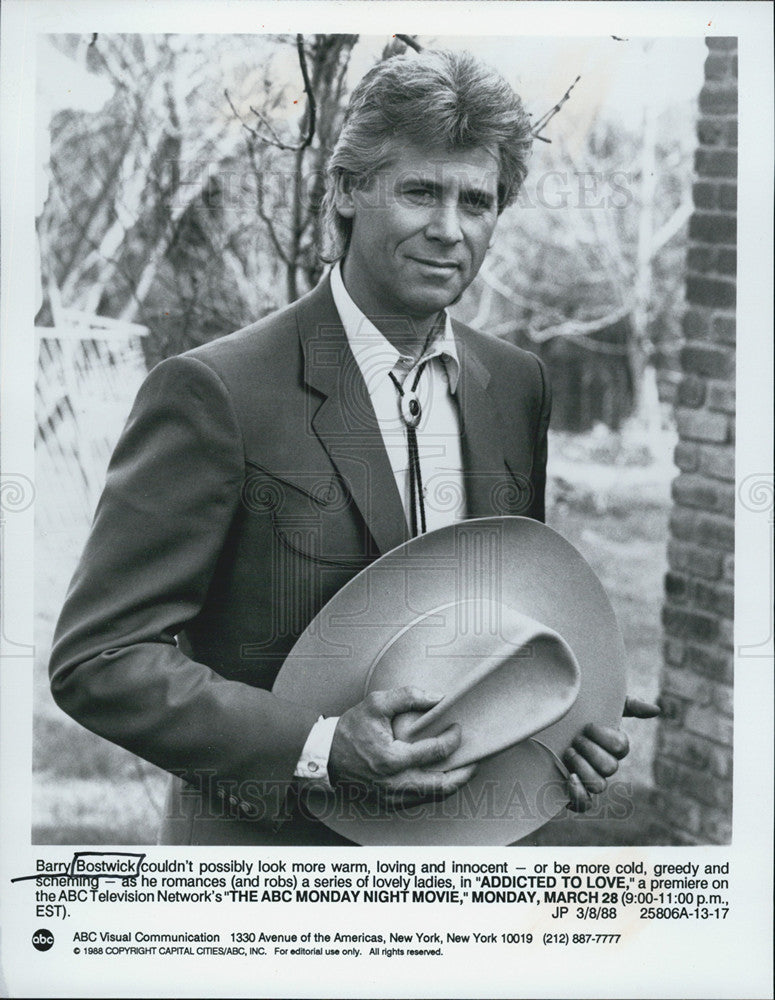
left=328, top=687, right=476, bottom=808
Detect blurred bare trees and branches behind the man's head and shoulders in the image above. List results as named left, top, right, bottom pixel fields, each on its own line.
left=39, top=35, right=699, bottom=410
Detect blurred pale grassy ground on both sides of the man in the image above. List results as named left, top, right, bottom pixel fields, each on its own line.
left=32, top=422, right=674, bottom=845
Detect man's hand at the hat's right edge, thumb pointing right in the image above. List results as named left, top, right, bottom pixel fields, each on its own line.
left=563, top=698, right=660, bottom=812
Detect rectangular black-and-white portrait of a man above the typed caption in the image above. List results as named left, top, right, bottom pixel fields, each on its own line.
left=27, top=27, right=737, bottom=845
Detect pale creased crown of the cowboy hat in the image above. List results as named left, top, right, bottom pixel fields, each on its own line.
left=363, top=600, right=580, bottom=769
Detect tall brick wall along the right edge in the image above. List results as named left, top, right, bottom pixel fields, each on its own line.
left=654, top=38, right=737, bottom=843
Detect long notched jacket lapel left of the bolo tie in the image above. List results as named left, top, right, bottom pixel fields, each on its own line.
left=298, top=278, right=409, bottom=555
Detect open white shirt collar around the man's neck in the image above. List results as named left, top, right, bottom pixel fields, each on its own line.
left=331, top=261, right=460, bottom=393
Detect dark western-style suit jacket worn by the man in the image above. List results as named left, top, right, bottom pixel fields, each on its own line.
left=51, top=280, right=550, bottom=843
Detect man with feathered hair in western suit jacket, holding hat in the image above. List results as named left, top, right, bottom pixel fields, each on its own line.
left=51, top=47, right=648, bottom=844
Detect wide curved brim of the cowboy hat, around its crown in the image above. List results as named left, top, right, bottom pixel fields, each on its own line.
left=273, top=517, right=626, bottom=846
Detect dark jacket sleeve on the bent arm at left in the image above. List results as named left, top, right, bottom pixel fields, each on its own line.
left=50, top=356, right=317, bottom=822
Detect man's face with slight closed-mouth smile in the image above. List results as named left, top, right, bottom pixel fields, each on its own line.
left=337, top=143, right=498, bottom=319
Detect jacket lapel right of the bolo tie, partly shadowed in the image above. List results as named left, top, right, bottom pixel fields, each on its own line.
left=453, top=324, right=511, bottom=517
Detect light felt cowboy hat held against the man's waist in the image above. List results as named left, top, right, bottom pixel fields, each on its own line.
left=273, top=517, right=625, bottom=845
